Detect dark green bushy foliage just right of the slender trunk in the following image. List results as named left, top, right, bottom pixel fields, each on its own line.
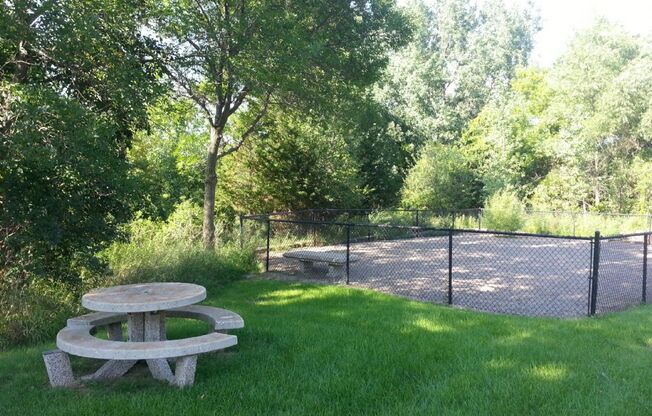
left=218, top=108, right=360, bottom=213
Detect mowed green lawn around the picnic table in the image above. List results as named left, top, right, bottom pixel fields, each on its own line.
left=0, top=280, right=652, bottom=415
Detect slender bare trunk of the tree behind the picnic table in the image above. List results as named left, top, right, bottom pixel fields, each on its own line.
left=202, top=126, right=223, bottom=250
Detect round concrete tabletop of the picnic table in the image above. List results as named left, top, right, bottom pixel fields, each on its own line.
left=82, top=283, right=206, bottom=312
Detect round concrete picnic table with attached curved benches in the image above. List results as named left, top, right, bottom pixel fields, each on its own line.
left=43, top=283, right=244, bottom=387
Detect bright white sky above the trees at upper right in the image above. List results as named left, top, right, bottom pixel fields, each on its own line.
left=506, top=0, right=652, bottom=67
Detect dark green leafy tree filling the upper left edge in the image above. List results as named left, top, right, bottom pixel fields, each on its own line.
left=0, top=0, right=157, bottom=280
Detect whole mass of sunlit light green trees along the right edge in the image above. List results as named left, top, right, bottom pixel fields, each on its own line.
left=464, top=20, right=652, bottom=212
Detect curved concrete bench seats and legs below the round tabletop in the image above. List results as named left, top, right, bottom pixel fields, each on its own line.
left=43, top=305, right=244, bottom=387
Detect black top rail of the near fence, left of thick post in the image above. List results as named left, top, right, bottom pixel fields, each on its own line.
left=248, top=216, right=594, bottom=241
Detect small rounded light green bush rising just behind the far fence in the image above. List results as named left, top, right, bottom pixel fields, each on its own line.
left=483, top=191, right=525, bottom=231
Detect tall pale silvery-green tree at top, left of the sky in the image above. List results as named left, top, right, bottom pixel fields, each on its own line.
left=377, top=0, right=538, bottom=142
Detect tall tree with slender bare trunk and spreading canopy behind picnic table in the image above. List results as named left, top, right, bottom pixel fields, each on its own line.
left=143, top=0, right=409, bottom=248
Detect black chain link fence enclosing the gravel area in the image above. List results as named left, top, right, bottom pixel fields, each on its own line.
left=240, top=210, right=652, bottom=317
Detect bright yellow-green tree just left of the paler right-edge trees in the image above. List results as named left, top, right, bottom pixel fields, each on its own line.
left=462, top=68, right=559, bottom=198
